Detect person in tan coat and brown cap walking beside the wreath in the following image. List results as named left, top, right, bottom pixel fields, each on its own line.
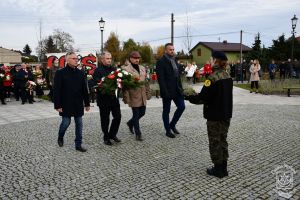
left=122, top=51, right=151, bottom=141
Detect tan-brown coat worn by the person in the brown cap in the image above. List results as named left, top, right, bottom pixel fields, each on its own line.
left=121, top=64, right=151, bottom=107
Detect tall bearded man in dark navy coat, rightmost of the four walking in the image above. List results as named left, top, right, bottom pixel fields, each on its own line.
left=156, top=43, right=185, bottom=138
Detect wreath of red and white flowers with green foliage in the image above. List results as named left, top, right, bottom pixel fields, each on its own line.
left=98, top=68, right=144, bottom=94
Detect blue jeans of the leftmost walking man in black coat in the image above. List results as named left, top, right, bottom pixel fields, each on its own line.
left=58, top=117, right=82, bottom=147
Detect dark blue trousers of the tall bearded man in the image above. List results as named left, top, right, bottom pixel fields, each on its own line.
left=162, top=95, right=185, bottom=133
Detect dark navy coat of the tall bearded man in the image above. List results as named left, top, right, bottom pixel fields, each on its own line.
left=156, top=55, right=183, bottom=98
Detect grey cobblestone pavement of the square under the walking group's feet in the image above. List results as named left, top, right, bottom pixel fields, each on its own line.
left=0, top=85, right=300, bottom=199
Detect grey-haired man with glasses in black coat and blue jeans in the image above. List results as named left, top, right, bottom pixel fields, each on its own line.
left=53, top=52, right=90, bottom=152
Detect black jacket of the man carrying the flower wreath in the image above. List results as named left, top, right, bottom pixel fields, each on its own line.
left=93, top=66, right=120, bottom=107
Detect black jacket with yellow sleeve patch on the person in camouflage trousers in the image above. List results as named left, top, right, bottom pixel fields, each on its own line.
left=188, top=67, right=233, bottom=121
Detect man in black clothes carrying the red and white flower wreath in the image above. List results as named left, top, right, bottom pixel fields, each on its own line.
left=93, top=52, right=121, bottom=145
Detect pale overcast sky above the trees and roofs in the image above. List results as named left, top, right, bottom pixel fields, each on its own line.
left=0, top=0, right=300, bottom=54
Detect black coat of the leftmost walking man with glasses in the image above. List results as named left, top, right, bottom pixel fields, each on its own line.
left=53, top=65, right=90, bottom=117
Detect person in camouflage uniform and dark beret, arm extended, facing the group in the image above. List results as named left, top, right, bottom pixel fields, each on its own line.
left=185, top=51, right=233, bottom=178
